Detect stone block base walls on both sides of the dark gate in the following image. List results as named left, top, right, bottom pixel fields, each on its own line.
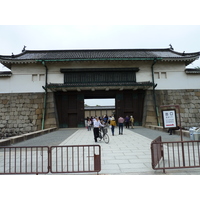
left=0, top=90, right=200, bottom=138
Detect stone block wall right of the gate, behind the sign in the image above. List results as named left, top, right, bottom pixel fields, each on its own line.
left=144, top=89, right=200, bottom=129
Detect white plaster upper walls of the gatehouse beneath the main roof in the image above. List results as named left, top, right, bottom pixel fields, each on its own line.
left=0, top=61, right=200, bottom=93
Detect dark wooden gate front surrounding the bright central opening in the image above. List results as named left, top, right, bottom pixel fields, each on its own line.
left=54, top=90, right=145, bottom=128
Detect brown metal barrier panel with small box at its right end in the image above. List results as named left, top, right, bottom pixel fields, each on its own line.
left=50, top=145, right=101, bottom=173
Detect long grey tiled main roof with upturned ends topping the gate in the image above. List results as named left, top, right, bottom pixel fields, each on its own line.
left=0, top=48, right=200, bottom=64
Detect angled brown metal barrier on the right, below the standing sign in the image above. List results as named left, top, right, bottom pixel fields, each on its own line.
left=151, top=137, right=200, bottom=172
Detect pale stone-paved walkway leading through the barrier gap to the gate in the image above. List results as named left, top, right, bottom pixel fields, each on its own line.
left=57, top=127, right=200, bottom=175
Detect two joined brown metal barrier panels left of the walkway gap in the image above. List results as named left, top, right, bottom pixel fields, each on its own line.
left=0, top=145, right=101, bottom=174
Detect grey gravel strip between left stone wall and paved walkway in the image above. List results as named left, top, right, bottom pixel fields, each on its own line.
left=12, top=129, right=78, bottom=146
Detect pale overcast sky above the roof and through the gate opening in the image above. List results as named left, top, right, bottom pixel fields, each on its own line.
left=0, top=25, right=200, bottom=105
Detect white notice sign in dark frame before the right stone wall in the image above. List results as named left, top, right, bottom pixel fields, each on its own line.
left=162, top=109, right=177, bottom=128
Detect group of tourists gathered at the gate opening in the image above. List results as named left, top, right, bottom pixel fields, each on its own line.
left=86, top=115, right=134, bottom=142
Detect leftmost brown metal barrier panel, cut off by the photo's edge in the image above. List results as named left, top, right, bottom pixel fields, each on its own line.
left=0, top=146, right=49, bottom=174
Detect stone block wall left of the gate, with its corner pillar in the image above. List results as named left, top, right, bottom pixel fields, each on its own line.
left=0, top=93, right=56, bottom=137
